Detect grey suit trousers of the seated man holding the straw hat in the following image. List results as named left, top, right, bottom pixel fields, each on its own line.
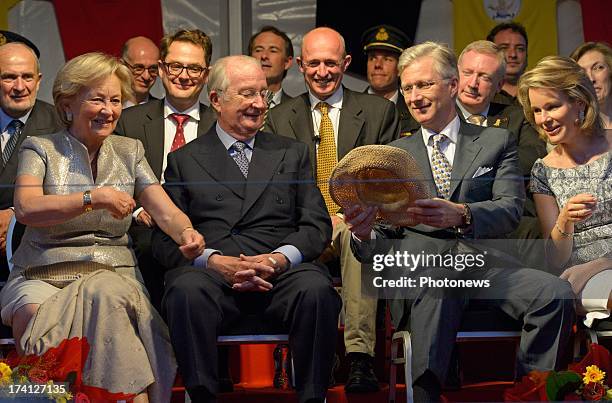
left=399, top=268, right=575, bottom=383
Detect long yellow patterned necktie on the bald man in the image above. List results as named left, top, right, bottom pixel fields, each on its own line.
left=316, top=102, right=340, bottom=215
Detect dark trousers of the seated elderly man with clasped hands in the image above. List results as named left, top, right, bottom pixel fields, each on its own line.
left=163, top=264, right=341, bottom=402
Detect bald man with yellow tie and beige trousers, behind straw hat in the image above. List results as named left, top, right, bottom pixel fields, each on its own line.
left=266, top=28, right=398, bottom=392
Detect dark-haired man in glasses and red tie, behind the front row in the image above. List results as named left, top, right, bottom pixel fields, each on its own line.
left=115, top=29, right=216, bottom=308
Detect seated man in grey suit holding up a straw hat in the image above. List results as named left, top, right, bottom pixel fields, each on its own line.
left=345, top=42, right=574, bottom=401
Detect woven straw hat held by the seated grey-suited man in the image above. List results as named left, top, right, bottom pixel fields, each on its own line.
left=329, top=145, right=432, bottom=226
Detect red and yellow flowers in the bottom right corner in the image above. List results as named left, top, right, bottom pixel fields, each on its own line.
left=504, top=344, right=612, bottom=402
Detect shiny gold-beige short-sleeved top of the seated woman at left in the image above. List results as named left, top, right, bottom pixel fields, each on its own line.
left=11, top=131, right=157, bottom=277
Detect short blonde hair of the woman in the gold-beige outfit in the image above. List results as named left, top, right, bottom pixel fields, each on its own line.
left=53, top=52, right=134, bottom=127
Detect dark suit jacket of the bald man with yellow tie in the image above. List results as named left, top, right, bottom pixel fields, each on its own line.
left=265, top=88, right=399, bottom=172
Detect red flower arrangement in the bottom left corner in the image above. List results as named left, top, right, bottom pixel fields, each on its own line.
left=0, top=337, right=134, bottom=403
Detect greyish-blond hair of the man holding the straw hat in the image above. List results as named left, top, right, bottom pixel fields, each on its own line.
left=397, top=41, right=459, bottom=79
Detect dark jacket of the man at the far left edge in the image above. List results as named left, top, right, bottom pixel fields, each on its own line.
left=0, top=100, right=62, bottom=210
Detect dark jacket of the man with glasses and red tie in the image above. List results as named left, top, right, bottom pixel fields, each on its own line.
left=115, top=99, right=217, bottom=179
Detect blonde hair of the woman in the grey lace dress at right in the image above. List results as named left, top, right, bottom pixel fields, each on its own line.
left=517, top=56, right=604, bottom=138
